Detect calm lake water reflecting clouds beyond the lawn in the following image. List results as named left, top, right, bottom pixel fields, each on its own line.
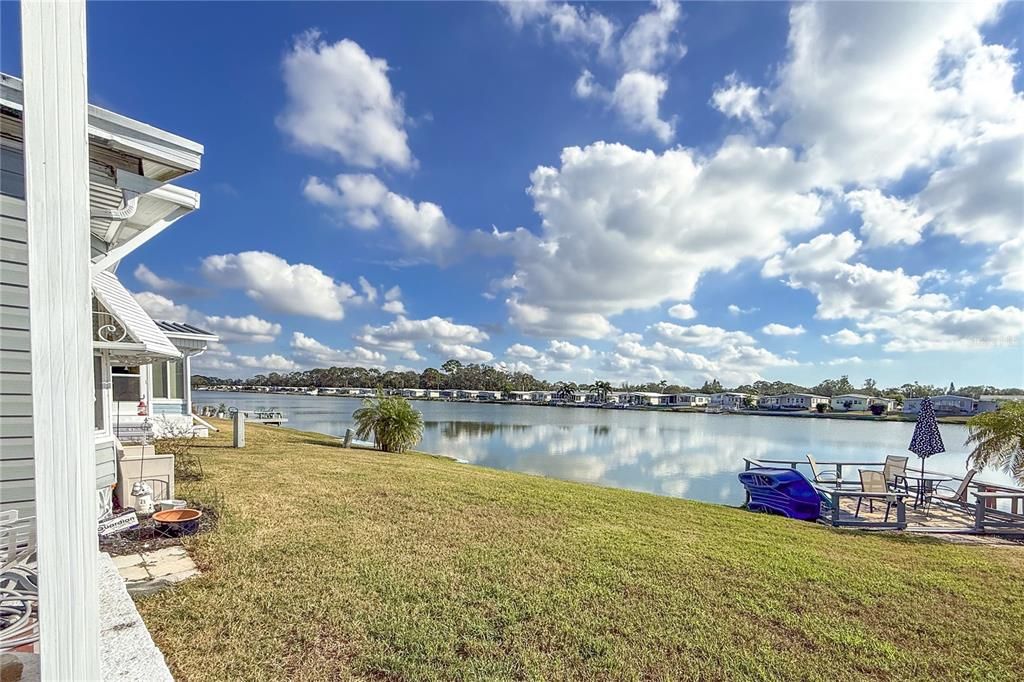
left=194, top=391, right=1010, bottom=504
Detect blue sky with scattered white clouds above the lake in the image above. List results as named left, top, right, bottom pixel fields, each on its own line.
left=0, top=0, right=1024, bottom=385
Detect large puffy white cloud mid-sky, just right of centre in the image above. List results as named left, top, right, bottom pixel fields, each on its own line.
left=490, top=138, right=825, bottom=338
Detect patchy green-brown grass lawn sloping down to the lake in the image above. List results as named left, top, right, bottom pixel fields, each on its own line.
left=139, top=422, right=1024, bottom=681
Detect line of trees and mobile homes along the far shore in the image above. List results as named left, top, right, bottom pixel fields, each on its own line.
left=193, top=359, right=1024, bottom=399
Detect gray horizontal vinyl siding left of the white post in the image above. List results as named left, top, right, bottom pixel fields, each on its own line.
left=0, top=191, right=36, bottom=515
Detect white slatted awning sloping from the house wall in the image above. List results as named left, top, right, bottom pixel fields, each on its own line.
left=92, top=271, right=181, bottom=366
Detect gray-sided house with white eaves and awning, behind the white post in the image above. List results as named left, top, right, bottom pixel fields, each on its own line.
left=0, top=69, right=203, bottom=516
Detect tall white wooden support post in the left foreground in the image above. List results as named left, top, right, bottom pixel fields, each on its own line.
left=22, top=0, right=100, bottom=680
